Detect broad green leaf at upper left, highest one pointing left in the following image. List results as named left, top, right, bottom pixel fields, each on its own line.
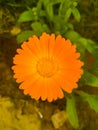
left=18, top=10, right=33, bottom=22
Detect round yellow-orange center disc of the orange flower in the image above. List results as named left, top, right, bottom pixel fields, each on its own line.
left=37, top=58, right=57, bottom=78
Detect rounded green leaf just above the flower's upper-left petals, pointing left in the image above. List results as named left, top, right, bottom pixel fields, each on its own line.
left=17, top=30, right=34, bottom=43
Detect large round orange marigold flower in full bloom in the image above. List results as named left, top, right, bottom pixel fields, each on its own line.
left=12, top=33, right=83, bottom=102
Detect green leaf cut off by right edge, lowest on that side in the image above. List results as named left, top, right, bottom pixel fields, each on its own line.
left=81, top=92, right=98, bottom=112
